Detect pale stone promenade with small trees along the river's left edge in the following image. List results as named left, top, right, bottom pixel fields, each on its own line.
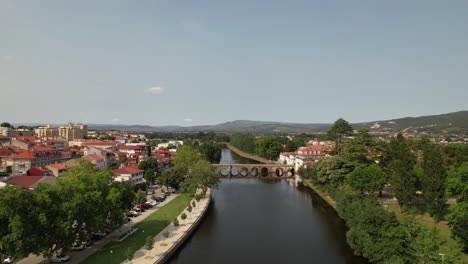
left=122, top=189, right=211, bottom=264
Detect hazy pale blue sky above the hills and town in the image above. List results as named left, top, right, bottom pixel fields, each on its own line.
left=0, top=0, right=468, bottom=126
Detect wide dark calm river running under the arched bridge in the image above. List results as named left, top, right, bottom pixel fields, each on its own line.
left=168, top=149, right=367, bottom=264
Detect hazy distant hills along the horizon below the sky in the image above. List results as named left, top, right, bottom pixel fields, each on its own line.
left=89, top=111, right=468, bottom=135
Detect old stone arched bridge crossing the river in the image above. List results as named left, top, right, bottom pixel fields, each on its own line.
left=213, top=164, right=295, bottom=179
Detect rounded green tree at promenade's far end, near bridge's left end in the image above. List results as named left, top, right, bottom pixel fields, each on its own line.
left=183, top=160, right=219, bottom=196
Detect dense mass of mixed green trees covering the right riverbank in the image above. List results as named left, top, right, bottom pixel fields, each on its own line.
left=299, top=119, right=468, bottom=263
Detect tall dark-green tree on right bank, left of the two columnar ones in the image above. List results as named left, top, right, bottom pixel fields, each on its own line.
left=387, top=133, right=418, bottom=207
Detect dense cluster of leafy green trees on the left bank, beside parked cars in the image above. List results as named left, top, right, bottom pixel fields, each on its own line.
left=0, top=161, right=135, bottom=260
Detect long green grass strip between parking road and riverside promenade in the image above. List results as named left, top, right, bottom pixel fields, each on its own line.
left=82, top=194, right=192, bottom=264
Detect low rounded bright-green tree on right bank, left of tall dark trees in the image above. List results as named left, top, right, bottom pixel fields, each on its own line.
left=345, top=164, right=386, bottom=194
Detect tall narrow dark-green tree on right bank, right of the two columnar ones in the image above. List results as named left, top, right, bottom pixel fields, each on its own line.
left=421, top=144, right=447, bottom=220
